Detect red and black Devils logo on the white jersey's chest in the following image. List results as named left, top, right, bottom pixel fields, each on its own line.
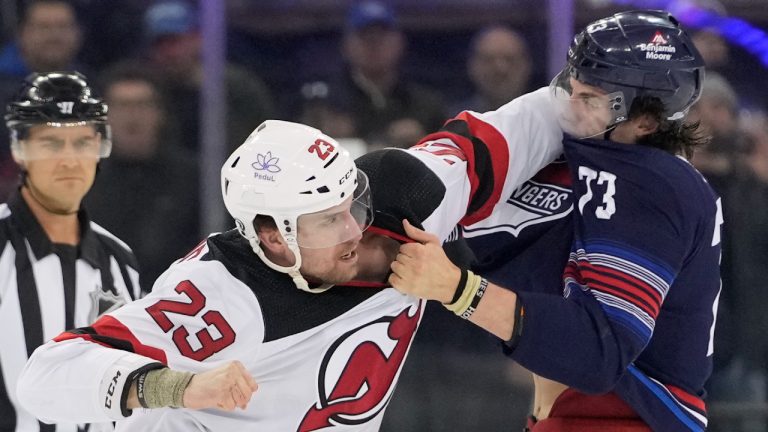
left=298, top=302, right=421, bottom=432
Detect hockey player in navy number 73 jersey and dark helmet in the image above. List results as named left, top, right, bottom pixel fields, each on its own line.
left=389, top=11, right=722, bottom=432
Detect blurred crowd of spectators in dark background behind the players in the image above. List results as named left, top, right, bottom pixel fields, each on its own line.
left=0, top=0, right=768, bottom=431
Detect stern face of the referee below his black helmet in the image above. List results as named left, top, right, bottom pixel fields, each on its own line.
left=20, top=125, right=101, bottom=212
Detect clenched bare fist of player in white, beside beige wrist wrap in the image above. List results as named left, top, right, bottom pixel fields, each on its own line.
left=184, top=361, right=259, bottom=411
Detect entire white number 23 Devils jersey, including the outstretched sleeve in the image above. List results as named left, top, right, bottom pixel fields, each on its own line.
left=13, top=89, right=562, bottom=431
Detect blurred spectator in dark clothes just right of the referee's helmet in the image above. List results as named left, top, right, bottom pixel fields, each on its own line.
left=86, top=63, right=200, bottom=292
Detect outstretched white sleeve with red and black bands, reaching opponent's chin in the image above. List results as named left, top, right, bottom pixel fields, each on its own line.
left=409, top=87, right=563, bottom=231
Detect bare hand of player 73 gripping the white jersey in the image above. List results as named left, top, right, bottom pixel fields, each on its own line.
left=389, top=220, right=461, bottom=303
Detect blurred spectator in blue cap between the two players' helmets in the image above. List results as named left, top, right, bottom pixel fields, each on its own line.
left=340, top=0, right=447, bottom=147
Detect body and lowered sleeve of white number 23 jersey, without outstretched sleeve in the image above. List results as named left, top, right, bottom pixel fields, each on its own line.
left=20, top=231, right=424, bottom=431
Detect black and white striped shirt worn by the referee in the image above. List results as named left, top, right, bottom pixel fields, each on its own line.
left=0, top=191, right=139, bottom=432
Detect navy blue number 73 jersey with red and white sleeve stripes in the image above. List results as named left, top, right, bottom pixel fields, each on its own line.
left=466, top=138, right=722, bottom=431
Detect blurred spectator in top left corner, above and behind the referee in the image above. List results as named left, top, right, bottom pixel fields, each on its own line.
left=0, top=0, right=83, bottom=201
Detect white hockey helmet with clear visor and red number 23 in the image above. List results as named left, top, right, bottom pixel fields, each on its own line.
left=221, top=120, right=373, bottom=292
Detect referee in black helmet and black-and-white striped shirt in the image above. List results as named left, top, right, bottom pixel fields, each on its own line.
left=0, top=72, right=139, bottom=432
